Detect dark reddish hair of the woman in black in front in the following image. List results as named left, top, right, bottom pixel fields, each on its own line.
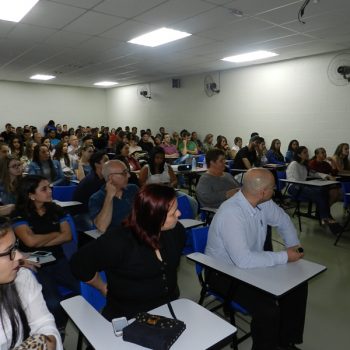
left=123, top=184, right=176, bottom=249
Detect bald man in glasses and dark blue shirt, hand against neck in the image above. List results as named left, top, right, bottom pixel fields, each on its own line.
left=89, top=160, right=138, bottom=232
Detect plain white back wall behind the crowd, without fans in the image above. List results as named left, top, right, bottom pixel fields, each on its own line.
left=0, top=81, right=107, bottom=130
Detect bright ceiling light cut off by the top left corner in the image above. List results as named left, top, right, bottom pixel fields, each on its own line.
left=0, top=0, right=39, bottom=22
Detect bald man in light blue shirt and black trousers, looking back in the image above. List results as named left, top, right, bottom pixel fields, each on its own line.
left=206, top=169, right=307, bottom=350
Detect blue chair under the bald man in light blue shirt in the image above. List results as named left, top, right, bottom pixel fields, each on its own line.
left=191, top=226, right=251, bottom=350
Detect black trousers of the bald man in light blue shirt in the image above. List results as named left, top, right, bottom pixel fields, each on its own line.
left=232, top=282, right=308, bottom=350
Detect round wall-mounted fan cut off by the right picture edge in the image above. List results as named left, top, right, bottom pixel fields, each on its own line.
left=327, top=52, right=350, bottom=86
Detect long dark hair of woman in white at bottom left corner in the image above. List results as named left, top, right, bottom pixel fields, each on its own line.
left=0, top=217, right=30, bottom=349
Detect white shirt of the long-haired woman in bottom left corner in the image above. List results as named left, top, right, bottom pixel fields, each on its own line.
left=0, top=268, right=63, bottom=350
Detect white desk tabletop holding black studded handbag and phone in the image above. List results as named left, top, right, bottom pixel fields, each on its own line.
left=61, top=295, right=236, bottom=350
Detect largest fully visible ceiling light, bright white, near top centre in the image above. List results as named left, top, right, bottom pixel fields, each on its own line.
left=128, top=27, right=192, bottom=47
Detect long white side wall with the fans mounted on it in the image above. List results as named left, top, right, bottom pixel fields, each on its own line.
left=107, top=54, right=350, bottom=154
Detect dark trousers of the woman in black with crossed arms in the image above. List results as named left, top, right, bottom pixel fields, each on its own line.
left=37, top=257, right=80, bottom=329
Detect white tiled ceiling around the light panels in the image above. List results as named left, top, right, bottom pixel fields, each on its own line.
left=0, top=0, right=350, bottom=87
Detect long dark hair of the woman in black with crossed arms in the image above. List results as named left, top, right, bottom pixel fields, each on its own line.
left=15, top=175, right=59, bottom=220
